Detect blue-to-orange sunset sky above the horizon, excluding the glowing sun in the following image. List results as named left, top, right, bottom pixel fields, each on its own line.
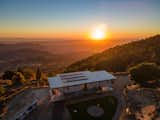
left=0, top=0, right=160, bottom=39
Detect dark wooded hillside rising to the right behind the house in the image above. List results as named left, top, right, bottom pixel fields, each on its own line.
left=65, top=35, right=160, bottom=72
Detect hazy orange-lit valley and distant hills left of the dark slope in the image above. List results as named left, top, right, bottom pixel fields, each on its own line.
left=0, top=38, right=133, bottom=72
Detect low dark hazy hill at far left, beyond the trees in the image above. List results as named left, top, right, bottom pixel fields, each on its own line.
left=0, top=44, right=62, bottom=72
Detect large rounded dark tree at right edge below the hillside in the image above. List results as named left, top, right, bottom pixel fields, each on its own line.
left=129, top=63, right=160, bottom=86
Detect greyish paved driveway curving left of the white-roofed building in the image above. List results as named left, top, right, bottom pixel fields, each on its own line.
left=4, top=88, right=49, bottom=120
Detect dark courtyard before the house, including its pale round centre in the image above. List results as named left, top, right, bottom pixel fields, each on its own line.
left=67, top=96, right=118, bottom=120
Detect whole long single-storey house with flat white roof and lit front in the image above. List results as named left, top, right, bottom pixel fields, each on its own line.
left=48, top=71, right=116, bottom=101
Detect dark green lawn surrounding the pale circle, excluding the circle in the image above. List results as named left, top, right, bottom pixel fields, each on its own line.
left=67, top=96, right=117, bottom=120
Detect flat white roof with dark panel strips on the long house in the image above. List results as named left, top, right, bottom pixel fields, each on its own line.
left=48, top=71, right=116, bottom=88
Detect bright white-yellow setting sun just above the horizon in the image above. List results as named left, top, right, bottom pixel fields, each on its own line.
left=90, top=25, right=107, bottom=40
